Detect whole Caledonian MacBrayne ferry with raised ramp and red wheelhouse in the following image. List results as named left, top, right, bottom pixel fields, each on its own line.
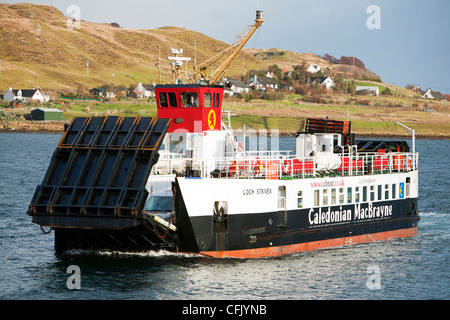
left=27, top=14, right=420, bottom=258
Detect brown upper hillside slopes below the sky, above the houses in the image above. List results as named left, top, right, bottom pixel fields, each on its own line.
left=0, top=4, right=376, bottom=91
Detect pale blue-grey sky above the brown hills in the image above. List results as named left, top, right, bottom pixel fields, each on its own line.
left=2, top=0, right=450, bottom=94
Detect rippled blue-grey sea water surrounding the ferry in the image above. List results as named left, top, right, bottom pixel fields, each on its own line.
left=0, top=133, right=450, bottom=301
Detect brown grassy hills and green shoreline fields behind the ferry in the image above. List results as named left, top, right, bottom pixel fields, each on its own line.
left=0, top=4, right=450, bottom=138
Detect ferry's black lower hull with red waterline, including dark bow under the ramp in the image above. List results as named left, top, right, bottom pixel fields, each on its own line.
left=44, top=193, right=420, bottom=258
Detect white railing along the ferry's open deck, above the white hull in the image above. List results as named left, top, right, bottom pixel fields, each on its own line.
left=152, top=152, right=419, bottom=180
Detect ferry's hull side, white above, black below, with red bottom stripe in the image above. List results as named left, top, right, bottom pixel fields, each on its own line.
left=177, top=173, right=420, bottom=258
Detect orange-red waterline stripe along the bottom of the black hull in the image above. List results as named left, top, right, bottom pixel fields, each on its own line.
left=200, top=227, right=418, bottom=258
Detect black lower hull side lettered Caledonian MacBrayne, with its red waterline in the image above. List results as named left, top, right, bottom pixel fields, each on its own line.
left=185, top=199, right=420, bottom=257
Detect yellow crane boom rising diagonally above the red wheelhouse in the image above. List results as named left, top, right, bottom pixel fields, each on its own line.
left=191, top=10, right=264, bottom=84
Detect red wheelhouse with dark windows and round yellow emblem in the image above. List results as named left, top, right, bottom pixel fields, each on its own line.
left=155, top=85, right=223, bottom=133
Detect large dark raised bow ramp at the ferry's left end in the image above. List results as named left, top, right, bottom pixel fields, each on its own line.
left=27, top=116, right=171, bottom=250
